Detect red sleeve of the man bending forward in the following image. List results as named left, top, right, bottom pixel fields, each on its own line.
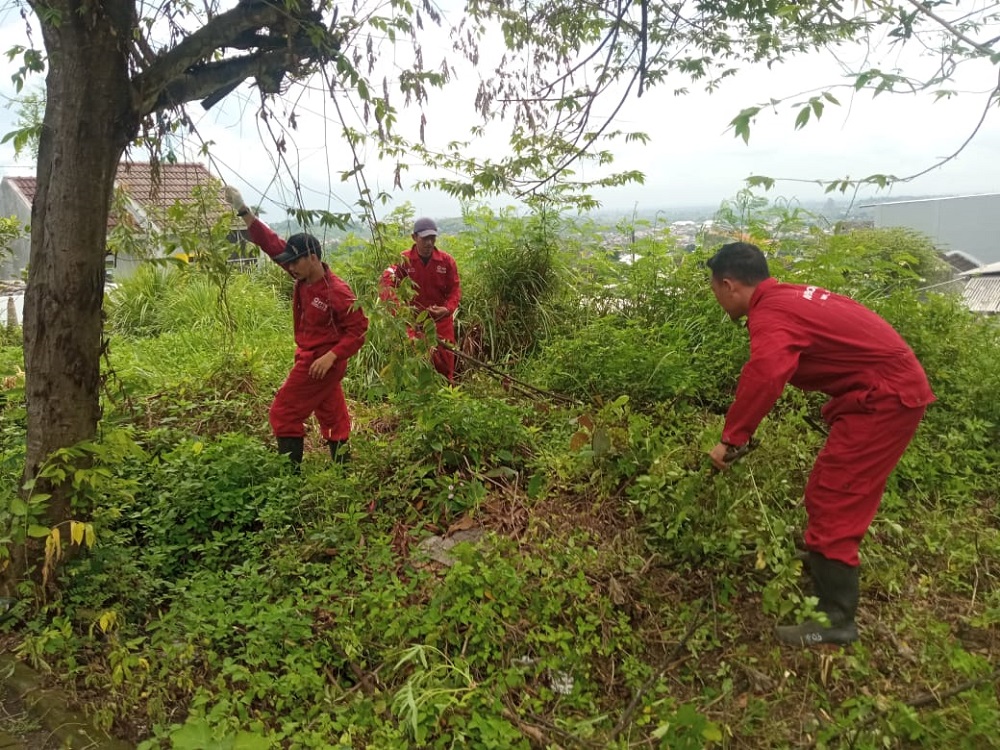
left=722, top=315, right=806, bottom=445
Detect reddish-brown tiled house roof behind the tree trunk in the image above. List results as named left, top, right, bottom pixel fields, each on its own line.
left=5, top=162, right=232, bottom=229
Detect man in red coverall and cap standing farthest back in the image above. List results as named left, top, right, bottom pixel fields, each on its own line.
left=381, top=218, right=462, bottom=382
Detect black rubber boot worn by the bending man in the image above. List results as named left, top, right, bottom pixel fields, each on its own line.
left=774, top=551, right=859, bottom=646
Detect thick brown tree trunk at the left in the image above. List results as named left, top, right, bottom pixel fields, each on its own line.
left=0, top=0, right=137, bottom=592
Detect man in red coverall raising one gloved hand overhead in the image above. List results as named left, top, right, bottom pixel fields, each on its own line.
left=226, top=187, right=368, bottom=467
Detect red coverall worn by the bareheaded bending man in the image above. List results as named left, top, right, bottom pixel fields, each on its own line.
left=722, top=279, right=934, bottom=566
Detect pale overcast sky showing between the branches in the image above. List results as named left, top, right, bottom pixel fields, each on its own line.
left=0, top=2, right=1000, bottom=220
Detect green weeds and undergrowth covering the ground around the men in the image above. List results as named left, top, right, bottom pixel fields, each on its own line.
left=0, top=210, right=1000, bottom=749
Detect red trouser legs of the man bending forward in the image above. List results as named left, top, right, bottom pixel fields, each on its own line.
left=805, top=391, right=927, bottom=566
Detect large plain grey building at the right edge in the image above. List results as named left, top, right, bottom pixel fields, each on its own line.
left=864, top=193, right=1000, bottom=265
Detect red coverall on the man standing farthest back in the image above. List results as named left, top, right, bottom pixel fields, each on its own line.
left=380, top=245, right=462, bottom=381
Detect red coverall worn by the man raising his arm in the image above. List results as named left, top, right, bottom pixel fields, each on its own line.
left=249, top=220, right=368, bottom=441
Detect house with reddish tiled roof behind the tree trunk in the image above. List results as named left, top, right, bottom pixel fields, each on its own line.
left=0, top=163, right=244, bottom=279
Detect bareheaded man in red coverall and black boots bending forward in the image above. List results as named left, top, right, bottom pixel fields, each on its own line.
left=708, top=242, right=934, bottom=645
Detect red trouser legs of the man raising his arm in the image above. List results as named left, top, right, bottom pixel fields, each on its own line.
left=269, top=354, right=351, bottom=440
